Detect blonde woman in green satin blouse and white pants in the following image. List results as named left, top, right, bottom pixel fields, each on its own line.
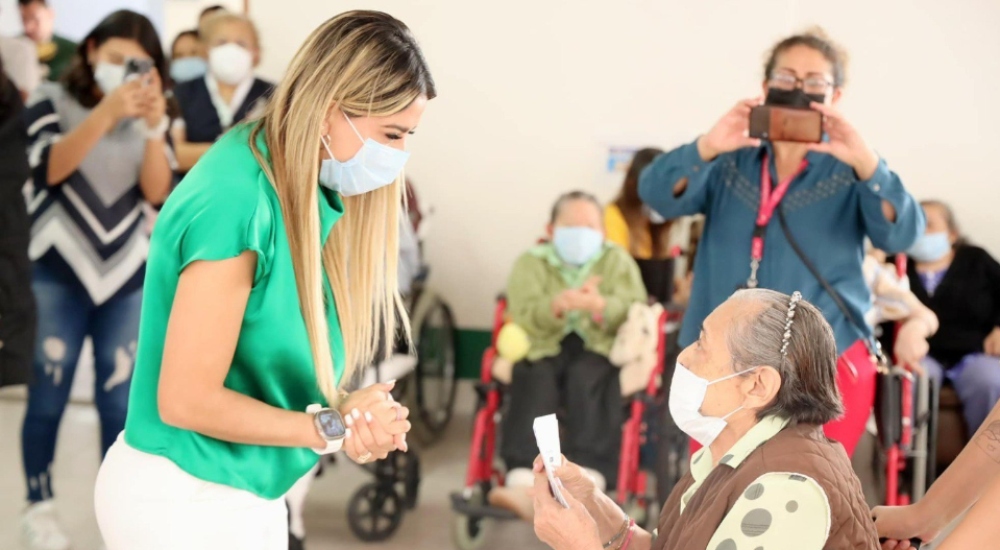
left=95, top=12, right=435, bottom=550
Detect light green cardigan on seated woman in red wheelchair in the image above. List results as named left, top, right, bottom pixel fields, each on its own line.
left=507, top=243, right=646, bottom=361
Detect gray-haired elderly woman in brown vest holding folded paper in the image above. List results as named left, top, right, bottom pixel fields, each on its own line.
left=535, top=289, right=878, bottom=550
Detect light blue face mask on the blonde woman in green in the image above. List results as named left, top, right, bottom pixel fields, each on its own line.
left=319, top=113, right=410, bottom=197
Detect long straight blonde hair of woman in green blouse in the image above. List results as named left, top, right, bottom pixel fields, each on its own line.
left=250, top=11, right=436, bottom=404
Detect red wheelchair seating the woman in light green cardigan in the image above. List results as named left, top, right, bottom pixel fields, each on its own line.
left=451, top=297, right=685, bottom=550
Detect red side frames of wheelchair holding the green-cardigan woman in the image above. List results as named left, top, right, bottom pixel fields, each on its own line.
left=451, top=297, right=670, bottom=548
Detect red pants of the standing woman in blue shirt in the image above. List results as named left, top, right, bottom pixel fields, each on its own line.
left=691, top=340, right=877, bottom=456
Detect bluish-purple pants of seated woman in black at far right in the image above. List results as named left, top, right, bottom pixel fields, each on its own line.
left=922, top=353, right=1000, bottom=434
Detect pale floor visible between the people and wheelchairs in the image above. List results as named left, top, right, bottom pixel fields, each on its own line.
left=0, top=388, right=545, bottom=550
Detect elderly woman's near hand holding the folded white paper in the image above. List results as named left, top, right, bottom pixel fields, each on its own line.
left=534, top=474, right=602, bottom=550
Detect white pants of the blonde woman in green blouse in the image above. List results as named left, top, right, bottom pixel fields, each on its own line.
left=94, top=436, right=288, bottom=550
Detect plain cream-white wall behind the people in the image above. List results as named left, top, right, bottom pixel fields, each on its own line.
left=251, top=0, right=1000, bottom=327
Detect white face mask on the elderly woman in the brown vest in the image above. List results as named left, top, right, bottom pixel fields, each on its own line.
left=669, top=363, right=756, bottom=447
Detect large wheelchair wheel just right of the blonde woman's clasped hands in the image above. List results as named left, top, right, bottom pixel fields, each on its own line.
left=410, top=296, right=458, bottom=445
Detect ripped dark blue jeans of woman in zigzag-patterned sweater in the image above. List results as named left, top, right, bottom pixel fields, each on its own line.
left=21, top=263, right=142, bottom=502
